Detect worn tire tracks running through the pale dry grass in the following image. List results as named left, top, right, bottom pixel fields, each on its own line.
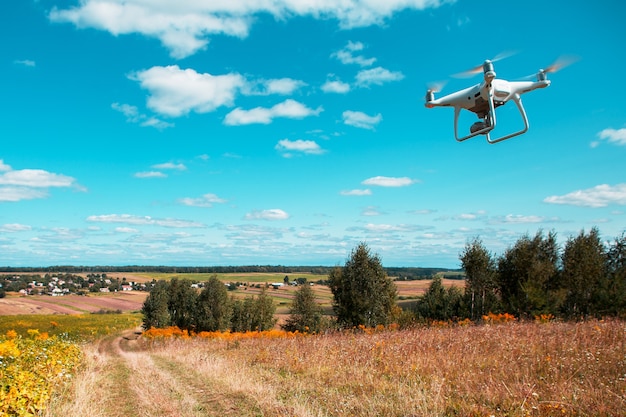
left=93, top=329, right=273, bottom=417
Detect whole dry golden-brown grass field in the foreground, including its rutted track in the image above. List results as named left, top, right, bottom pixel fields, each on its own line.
left=42, top=321, right=626, bottom=417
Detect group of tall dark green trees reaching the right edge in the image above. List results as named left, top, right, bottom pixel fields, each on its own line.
left=432, top=228, right=626, bottom=320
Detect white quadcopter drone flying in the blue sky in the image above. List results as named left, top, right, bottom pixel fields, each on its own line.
left=425, top=57, right=573, bottom=144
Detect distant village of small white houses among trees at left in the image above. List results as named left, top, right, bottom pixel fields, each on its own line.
left=0, top=273, right=146, bottom=297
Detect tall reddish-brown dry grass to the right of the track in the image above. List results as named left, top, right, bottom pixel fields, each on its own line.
left=151, top=321, right=626, bottom=416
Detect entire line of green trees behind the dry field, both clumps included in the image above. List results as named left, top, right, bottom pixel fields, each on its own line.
left=143, top=228, right=626, bottom=332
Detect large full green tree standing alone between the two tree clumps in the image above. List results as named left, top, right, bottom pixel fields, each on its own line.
left=328, top=243, right=397, bottom=327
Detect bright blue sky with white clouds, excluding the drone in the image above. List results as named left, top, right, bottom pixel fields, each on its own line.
left=0, top=0, right=626, bottom=268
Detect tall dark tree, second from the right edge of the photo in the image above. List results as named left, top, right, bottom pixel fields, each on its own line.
left=561, top=227, right=607, bottom=317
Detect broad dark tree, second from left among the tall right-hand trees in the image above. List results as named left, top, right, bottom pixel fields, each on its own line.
left=498, top=230, right=559, bottom=317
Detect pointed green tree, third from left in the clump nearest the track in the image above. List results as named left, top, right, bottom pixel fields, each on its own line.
left=195, top=275, right=231, bottom=332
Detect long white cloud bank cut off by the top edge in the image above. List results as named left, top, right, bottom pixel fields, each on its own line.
left=49, top=0, right=445, bottom=59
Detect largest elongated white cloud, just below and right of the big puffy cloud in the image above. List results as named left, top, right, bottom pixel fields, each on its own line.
left=224, top=99, right=323, bottom=126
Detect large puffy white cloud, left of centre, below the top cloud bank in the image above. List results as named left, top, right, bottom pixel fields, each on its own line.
left=129, top=65, right=245, bottom=117
